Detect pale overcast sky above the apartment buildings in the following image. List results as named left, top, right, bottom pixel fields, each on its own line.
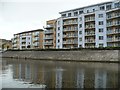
left=0, top=0, right=110, bottom=39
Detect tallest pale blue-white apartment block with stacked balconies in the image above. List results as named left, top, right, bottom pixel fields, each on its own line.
left=56, top=0, right=120, bottom=48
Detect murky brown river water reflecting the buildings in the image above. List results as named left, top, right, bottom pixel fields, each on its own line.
left=0, top=58, right=118, bottom=88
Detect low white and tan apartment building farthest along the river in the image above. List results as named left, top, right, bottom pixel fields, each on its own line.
left=12, top=29, right=43, bottom=49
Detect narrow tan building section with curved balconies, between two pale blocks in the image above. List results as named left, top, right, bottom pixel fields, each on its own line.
left=44, top=19, right=56, bottom=49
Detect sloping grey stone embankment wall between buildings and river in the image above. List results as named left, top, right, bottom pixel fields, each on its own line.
left=2, top=50, right=119, bottom=62
